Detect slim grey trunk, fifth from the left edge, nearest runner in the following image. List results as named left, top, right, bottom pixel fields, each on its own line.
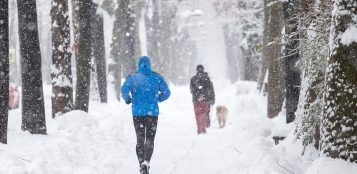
left=92, top=3, right=107, bottom=103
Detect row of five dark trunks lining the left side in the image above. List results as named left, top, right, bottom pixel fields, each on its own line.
left=0, top=0, right=107, bottom=143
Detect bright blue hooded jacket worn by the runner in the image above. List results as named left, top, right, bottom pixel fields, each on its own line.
left=121, top=56, right=171, bottom=116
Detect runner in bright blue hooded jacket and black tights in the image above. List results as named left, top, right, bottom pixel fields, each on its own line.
left=121, top=56, right=171, bottom=174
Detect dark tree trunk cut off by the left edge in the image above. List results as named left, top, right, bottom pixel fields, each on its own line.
left=0, top=0, right=9, bottom=144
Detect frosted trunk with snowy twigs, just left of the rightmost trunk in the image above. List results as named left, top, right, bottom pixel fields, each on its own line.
left=296, top=0, right=331, bottom=149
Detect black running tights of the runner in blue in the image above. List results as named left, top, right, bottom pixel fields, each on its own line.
left=133, top=116, right=158, bottom=165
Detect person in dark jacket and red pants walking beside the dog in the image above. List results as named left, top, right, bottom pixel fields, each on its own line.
left=190, top=65, right=215, bottom=134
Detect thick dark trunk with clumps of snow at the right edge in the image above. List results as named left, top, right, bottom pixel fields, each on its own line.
left=321, top=0, right=357, bottom=163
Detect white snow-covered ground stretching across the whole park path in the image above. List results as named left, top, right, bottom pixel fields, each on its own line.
left=0, top=82, right=357, bottom=174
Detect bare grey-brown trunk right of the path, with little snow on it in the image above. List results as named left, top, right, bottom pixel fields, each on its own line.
left=265, top=0, right=285, bottom=118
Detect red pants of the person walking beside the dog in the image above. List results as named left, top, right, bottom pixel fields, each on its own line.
left=193, top=102, right=208, bottom=134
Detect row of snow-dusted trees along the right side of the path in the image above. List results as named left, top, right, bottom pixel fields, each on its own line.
left=258, top=0, right=357, bottom=162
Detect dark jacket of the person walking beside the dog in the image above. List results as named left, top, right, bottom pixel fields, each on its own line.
left=190, top=72, right=215, bottom=104
